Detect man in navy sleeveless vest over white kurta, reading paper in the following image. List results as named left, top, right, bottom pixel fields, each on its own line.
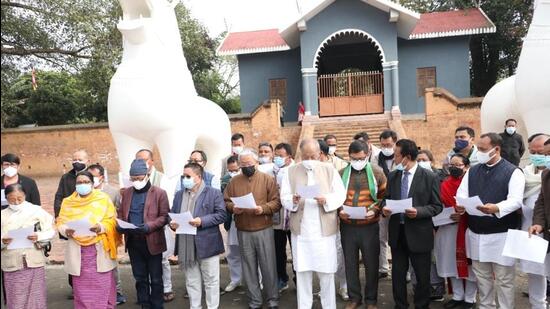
left=456, top=133, right=525, bottom=309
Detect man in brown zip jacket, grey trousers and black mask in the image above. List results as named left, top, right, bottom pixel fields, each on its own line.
left=224, top=149, right=281, bottom=308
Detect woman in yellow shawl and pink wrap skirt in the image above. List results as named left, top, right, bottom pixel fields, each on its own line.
left=57, top=171, right=120, bottom=309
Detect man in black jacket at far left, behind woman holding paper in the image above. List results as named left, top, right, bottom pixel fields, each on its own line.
left=1, top=153, right=40, bottom=209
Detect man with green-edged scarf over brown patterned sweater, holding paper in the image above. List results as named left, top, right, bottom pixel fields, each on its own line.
left=338, top=141, right=386, bottom=309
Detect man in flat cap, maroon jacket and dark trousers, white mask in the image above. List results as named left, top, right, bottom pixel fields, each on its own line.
left=117, top=159, right=170, bottom=309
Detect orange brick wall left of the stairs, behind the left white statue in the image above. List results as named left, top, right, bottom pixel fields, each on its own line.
left=1, top=102, right=301, bottom=176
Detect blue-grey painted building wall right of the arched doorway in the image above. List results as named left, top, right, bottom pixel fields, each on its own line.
left=397, top=36, right=470, bottom=114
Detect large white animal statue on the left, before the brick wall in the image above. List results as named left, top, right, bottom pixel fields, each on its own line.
left=108, top=0, right=231, bottom=193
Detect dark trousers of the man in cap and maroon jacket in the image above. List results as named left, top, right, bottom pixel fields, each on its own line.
left=128, top=238, right=164, bottom=309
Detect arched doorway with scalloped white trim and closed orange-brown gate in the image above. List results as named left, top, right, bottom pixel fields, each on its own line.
left=314, top=29, right=385, bottom=116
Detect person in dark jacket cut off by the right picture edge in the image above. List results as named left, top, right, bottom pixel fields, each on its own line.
left=529, top=140, right=550, bottom=240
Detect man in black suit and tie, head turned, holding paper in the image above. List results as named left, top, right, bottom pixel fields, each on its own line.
left=382, top=139, right=443, bottom=308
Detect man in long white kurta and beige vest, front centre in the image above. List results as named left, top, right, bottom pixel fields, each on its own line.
left=281, top=139, right=346, bottom=309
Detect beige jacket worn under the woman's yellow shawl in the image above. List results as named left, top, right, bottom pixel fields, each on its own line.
left=59, top=224, right=117, bottom=276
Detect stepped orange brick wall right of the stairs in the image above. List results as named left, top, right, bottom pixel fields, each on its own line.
left=402, top=88, right=482, bottom=164
